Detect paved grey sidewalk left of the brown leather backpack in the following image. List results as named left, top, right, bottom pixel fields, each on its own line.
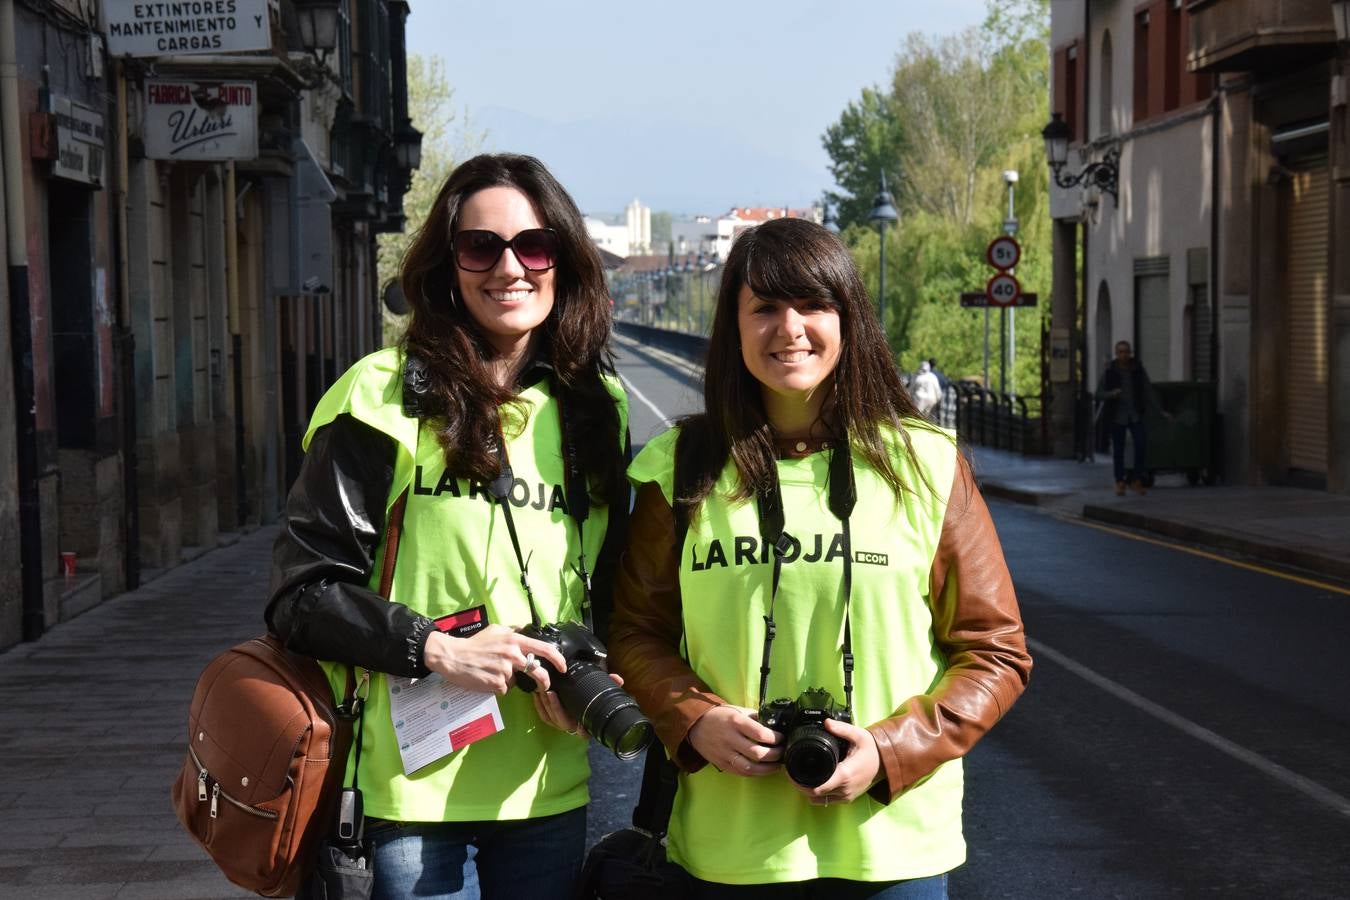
left=0, top=526, right=277, bottom=900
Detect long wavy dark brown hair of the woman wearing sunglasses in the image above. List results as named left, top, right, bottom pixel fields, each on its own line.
left=401, top=154, right=624, bottom=502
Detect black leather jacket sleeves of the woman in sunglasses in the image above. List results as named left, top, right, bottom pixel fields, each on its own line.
left=265, top=396, right=629, bottom=677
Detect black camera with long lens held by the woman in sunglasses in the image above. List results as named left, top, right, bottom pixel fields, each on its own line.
left=516, top=622, right=655, bottom=760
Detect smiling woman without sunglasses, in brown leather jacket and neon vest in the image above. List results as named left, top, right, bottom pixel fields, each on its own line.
left=610, top=219, right=1031, bottom=900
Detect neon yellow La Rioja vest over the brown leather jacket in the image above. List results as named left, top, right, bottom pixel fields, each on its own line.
left=629, top=424, right=965, bottom=884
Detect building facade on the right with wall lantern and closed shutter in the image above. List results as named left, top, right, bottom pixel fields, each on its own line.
left=1050, top=0, right=1350, bottom=493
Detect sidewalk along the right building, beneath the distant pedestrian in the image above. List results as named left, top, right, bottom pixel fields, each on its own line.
left=971, top=447, right=1350, bottom=580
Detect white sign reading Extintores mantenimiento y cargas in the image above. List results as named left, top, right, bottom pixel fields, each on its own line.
left=103, top=0, right=271, bottom=57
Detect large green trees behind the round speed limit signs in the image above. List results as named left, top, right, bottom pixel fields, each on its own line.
left=822, top=0, right=1050, bottom=395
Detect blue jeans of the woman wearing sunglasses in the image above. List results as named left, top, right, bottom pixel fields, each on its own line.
left=366, top=807, right=586, bottom=900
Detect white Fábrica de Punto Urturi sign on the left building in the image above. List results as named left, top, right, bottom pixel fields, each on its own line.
left=143, top=78, right=258, bottom=161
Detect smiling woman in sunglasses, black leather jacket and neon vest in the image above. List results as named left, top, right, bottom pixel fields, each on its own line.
left=266, top=155, right=628, bottom=899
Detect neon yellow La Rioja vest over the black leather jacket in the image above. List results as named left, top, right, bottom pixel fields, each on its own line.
left=304, top=348, right=628, bottom=822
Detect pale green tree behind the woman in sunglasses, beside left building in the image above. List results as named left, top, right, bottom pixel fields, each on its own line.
left=377, top=54, right=486, bottom=345
